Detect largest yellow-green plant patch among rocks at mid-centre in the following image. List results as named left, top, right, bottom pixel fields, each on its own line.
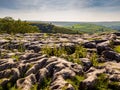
left=42, top=45, right=87, bottom=64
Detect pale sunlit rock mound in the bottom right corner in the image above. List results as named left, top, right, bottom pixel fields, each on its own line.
left=79, top=62, right=120, bottom=90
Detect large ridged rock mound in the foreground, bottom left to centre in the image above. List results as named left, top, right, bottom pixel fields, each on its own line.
left=0, top=54, right=83, bottom=90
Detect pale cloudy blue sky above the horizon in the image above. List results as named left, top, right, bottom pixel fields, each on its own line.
left=0, top=0, right=120, bottom=22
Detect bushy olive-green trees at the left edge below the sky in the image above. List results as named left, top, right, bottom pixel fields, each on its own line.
left=0, top=17, right=40, bottom=34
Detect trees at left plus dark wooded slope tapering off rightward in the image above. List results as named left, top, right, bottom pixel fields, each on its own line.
left=0, top=17, right=78, bottom=34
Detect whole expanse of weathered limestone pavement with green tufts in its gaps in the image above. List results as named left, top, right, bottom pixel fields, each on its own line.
left=0, top=33, right=120, bottom=90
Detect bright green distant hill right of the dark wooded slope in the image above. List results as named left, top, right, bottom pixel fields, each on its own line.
left=66, top=23, right=117, bottom=34
